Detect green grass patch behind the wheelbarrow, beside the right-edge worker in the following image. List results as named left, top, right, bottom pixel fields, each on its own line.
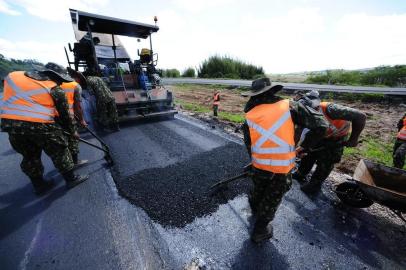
left=344, top=137, right=393, bottom=166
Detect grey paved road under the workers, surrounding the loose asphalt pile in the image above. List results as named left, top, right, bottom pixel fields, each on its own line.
left=0, top=116, right=406, bottom=269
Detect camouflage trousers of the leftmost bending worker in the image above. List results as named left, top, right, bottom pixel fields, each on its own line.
left=9, top=132, right=73, bottom=178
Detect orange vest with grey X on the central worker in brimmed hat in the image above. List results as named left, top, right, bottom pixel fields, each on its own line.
left=245, top=99, right=296, bottom=174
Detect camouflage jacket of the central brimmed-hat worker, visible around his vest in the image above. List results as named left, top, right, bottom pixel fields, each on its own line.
left=242, top=95, right=328, bottom=154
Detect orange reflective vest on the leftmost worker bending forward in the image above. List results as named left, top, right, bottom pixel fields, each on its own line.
left=0, top=71, right=58, bottom=123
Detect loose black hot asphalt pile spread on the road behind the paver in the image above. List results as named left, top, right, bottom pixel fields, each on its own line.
left=116, top=143, right=251, bottom=227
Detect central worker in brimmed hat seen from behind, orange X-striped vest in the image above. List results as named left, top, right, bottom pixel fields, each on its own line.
left=242, top=78, right=328, bottom=243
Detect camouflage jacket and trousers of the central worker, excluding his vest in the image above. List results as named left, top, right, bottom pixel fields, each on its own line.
left=242, top=95, right=328, bottom=226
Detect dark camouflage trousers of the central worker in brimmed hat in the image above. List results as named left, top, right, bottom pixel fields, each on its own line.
left=249, top=169, right=292, bottom=224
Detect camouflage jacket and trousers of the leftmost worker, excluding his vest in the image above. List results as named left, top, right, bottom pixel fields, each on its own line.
left=1, top=81, right=74, bottom=180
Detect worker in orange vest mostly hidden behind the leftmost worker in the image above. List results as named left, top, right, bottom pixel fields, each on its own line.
left=45, top=62, right=87, bottom=167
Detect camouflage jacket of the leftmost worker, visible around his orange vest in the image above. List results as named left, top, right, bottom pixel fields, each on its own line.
left=1, top=86, right=74, bottom=134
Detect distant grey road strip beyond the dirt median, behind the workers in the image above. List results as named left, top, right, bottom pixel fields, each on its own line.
left=163, top=78, right=406, bottom=96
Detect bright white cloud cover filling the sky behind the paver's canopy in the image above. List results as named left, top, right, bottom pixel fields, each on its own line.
left=0, top=0, right=406, bottom=73
